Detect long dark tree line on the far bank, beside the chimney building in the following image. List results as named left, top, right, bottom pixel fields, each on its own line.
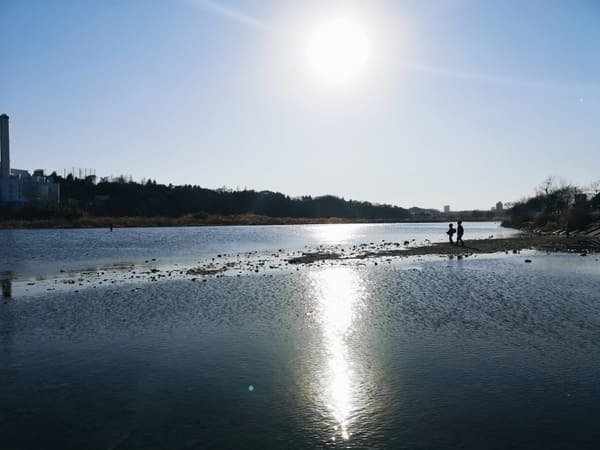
left=27, top=173, right=410, bottom=220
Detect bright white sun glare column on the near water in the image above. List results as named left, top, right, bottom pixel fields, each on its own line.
left=313, top=267, right=364, bottom=440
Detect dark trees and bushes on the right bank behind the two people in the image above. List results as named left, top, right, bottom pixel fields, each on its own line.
left=506, top=176, right=600, bottom=230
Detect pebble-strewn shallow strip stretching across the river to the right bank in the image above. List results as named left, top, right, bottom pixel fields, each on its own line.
left=1, top=234, right=600, bottom=303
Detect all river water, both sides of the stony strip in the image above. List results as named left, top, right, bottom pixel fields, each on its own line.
left=0, top=223, right=600, bottom=449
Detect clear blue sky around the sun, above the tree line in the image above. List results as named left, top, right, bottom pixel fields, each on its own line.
left=0, top=0, right=600, bottom=210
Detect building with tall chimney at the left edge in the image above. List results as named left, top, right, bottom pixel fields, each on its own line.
left=0, top=114, right=60, bottom=205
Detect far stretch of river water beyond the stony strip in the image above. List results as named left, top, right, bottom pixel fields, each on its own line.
left=0, top=222, right=518, bottom=279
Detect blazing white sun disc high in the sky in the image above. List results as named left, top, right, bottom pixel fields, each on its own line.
left=306, top=18, right=369, bottom=83
